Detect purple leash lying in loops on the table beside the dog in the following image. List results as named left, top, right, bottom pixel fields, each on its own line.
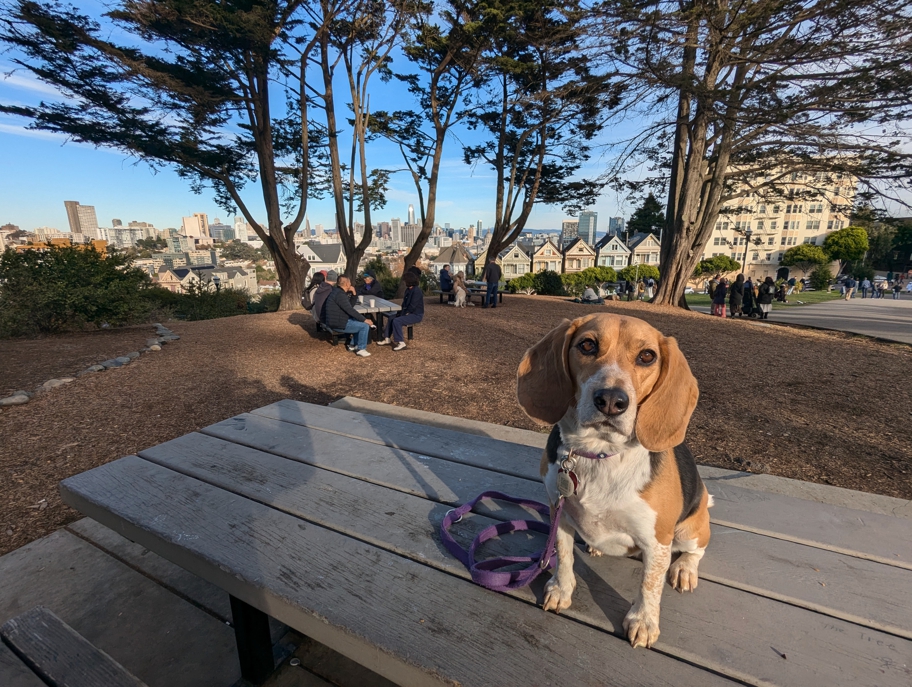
left=440, top=491, right=564, bottom=592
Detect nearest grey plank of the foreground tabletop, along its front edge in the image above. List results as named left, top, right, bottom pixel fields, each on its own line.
left=61, top=456, right=727, bottom=687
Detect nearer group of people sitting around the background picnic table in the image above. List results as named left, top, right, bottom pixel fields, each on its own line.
left=301, top=267, right=424, bottom=358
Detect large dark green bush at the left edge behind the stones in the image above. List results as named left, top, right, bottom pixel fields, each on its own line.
left=0, top=246, right=152, bottom=337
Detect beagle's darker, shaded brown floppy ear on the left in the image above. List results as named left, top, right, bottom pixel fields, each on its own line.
left=516, top=320, right=580, bottom=425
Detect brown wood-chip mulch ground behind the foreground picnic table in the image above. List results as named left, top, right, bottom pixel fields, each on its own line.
left=0, top=296, right=912, bottom=554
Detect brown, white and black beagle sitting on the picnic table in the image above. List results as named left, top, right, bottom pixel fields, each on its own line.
left=517, top=313, right=712, bottom=647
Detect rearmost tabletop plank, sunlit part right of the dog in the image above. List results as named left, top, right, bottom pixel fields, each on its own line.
left=707, top=482, right=912, bottom=570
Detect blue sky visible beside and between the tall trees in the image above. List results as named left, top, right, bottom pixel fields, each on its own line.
left=0, top=61, right=631, bottom=236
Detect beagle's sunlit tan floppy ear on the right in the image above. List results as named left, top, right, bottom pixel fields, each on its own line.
left=636, top=336, right=700, bottom=452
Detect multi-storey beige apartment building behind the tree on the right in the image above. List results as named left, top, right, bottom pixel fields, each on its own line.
left=700, top=172, right=857, bottom=280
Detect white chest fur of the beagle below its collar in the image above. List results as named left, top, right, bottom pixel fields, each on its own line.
left=545, top=449, right=656, bottom=556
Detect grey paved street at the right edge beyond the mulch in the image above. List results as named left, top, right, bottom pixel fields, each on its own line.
left=694, top=294, right=912, bottom=344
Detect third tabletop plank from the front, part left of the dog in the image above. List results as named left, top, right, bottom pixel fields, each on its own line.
left=200, top=414, right=546, bottom=512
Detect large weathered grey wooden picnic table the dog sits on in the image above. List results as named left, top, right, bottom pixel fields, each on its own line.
left=60, top=400, right=912, bottom=687
